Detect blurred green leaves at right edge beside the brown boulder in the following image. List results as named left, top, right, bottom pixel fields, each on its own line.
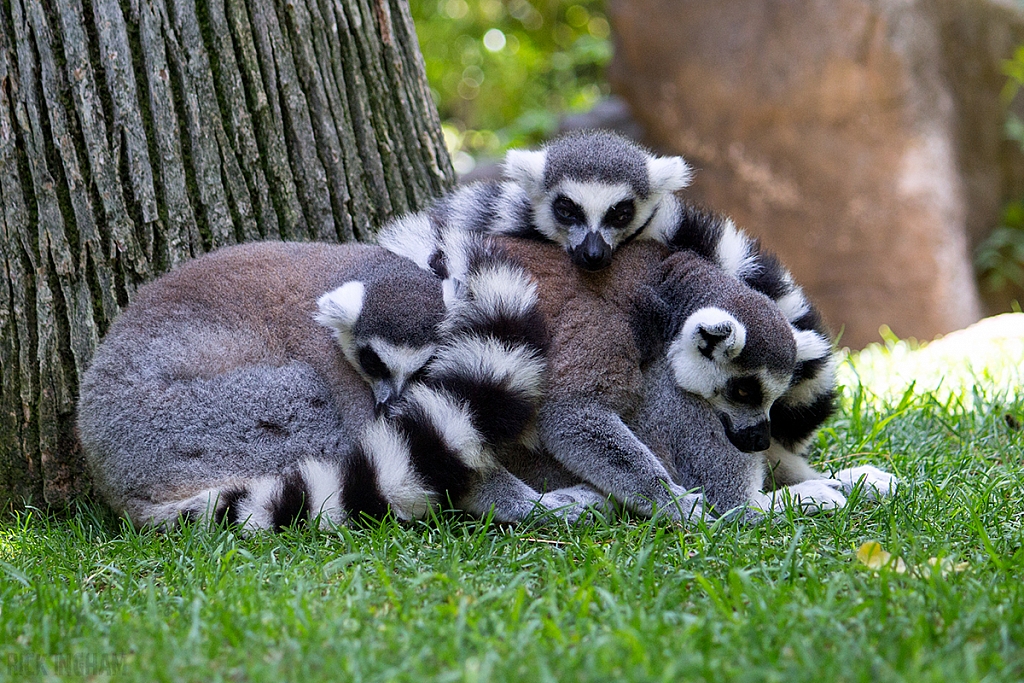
left=974, top=46, right=1024, bottom=292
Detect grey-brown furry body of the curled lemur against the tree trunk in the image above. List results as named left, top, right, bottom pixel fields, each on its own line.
left=78, top=243, right=443, bottom=523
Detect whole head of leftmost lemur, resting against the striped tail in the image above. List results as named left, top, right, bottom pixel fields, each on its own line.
left=315, top=264, right=444, bottom=414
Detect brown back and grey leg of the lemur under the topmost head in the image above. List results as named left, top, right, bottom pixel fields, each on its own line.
left=466, top=240, right=700, bottom=518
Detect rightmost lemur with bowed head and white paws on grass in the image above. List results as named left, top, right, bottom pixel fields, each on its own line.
left=633, top=246, right=896, bottom=510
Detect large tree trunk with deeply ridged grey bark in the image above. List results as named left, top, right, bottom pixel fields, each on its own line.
left=0, top=0, right=454, bottom=506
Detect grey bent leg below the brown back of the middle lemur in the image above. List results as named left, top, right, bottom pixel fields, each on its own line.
left=539, top=396, right=703, bottom=519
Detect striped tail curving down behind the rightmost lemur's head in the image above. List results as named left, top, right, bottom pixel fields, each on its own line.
left=659, top=197, right=836, bottom=454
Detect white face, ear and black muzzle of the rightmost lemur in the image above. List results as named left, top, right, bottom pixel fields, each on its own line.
left=668, top=307, right=793, bottom=453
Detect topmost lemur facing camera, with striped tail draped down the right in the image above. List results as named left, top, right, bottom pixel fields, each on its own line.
left=381, top=131, right=836, bottom=484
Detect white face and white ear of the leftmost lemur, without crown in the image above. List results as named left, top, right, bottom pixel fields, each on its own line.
left=315, top=282, right=436, bottom=413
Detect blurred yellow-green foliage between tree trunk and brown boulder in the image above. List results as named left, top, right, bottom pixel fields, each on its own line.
left=410, top=0, right=611, bottom=172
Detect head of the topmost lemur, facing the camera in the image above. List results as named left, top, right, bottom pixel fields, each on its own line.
left=505, top=131, right=690, bottom=270
